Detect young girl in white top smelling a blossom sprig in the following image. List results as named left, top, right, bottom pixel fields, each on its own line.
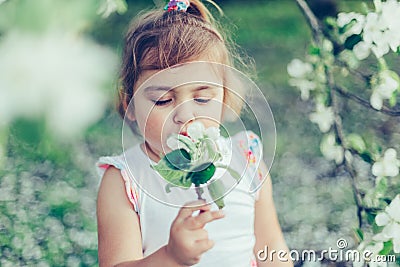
left=97, top=0, right=292, bottom=267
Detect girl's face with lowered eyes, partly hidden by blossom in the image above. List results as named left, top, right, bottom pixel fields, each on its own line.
left=131, top=62, right=224, bottom=162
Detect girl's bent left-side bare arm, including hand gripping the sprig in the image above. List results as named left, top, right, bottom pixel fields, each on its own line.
left=97, top=167, right=223, bottom=267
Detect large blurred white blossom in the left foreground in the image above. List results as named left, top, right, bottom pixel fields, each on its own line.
left=0, top=32, right=117, bottom=137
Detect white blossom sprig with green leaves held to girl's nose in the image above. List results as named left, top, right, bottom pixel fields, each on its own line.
left=151, top=121, right=240, bottom=209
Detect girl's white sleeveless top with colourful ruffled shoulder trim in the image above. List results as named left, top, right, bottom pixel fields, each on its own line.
left=97, top=131, right=264, bottom=267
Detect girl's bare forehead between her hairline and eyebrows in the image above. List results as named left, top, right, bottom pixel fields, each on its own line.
left=137, top=61, right=226, bottom=91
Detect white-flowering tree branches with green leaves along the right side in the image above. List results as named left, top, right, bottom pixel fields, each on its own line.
left=287, top=0, right=400, bottom=266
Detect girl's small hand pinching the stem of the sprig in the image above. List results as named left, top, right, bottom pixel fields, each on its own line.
left=166, top=200, right=224, bottom=266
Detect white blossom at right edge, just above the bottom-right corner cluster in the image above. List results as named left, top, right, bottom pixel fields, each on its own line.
left=372, top=148, right=400, bottom=177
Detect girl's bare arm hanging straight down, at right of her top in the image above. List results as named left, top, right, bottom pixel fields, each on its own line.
left=254, top=163, right=293, bottom=267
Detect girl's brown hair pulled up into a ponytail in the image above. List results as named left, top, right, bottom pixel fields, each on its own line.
left=117, top=0, right=253, bottom=129
